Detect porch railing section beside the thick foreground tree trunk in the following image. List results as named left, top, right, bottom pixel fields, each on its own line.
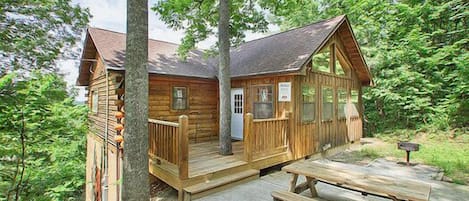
left=148, top=115, right=189, bottom=179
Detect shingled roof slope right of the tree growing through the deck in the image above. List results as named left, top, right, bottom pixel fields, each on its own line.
left=231, top=16, right=344, bottom=77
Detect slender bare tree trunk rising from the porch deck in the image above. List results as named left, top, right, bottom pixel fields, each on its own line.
left=218, top=0, right=232, bottom=155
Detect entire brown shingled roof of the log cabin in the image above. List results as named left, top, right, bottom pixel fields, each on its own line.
left=77, top=16, right=371, bottom=85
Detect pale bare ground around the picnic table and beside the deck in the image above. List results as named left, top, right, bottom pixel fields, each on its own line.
left=151, top=138, right=469, bottom=201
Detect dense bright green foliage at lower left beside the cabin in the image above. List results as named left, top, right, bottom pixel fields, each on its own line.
left=0, top=73, right=87, bottom=200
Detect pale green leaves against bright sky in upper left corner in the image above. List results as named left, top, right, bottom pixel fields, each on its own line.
left=0, top=0, right=90, bottom=76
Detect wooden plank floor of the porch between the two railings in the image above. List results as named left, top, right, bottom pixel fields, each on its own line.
left=189, top=141, right=247, bottom=177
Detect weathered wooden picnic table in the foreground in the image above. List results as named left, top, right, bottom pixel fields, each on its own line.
left=282, top=161, right=431, bottom=201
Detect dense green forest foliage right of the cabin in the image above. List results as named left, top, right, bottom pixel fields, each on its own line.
left=263, top=0, right=469, bottom=133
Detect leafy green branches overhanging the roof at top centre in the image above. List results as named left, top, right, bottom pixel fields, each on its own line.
left=152, top=0, right=268, bottom=58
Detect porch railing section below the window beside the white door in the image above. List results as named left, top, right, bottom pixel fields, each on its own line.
left=244, top=113, right=292, bottom=161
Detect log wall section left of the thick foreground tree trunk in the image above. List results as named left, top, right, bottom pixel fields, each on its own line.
left=87, top=51, right=121, bottom=146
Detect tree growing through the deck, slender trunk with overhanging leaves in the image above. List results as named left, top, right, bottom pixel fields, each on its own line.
left=152, top=0, right=268, bottom=155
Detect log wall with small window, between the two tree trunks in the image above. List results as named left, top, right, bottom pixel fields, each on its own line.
left=148, top=74, right=218, bottom=142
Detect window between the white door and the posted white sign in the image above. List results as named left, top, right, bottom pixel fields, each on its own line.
left=254, top=85, right=274, bottom=119
